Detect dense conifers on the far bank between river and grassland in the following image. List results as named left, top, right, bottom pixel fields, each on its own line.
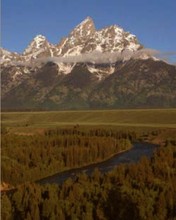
left=1, top=126, right=134, bottom=185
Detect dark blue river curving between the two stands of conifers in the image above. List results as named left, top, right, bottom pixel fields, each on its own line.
left=37, top=143, right=157, bottom=184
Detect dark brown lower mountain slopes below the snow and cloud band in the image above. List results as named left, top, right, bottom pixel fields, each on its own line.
left=2, top=59, right=176, bottom=110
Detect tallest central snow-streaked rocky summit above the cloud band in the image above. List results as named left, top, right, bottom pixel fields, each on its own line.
left=56, top=17, right=142, bottom=57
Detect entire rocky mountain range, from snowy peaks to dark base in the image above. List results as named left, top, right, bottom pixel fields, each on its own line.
left=0, top=17, right=176, bottom=109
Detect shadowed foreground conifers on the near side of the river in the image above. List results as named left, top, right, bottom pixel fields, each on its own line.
left=2, top=140, right=176, bottom=220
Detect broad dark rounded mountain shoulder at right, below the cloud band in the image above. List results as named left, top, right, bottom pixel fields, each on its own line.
left=90, top=59, right=176, bottom=108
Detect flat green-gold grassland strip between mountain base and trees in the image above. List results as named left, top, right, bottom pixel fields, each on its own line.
left=1, top=109, right=176, bottom=133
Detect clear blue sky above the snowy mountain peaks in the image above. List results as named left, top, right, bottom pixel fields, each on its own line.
left=1, top=0, right=176, bottom=62
